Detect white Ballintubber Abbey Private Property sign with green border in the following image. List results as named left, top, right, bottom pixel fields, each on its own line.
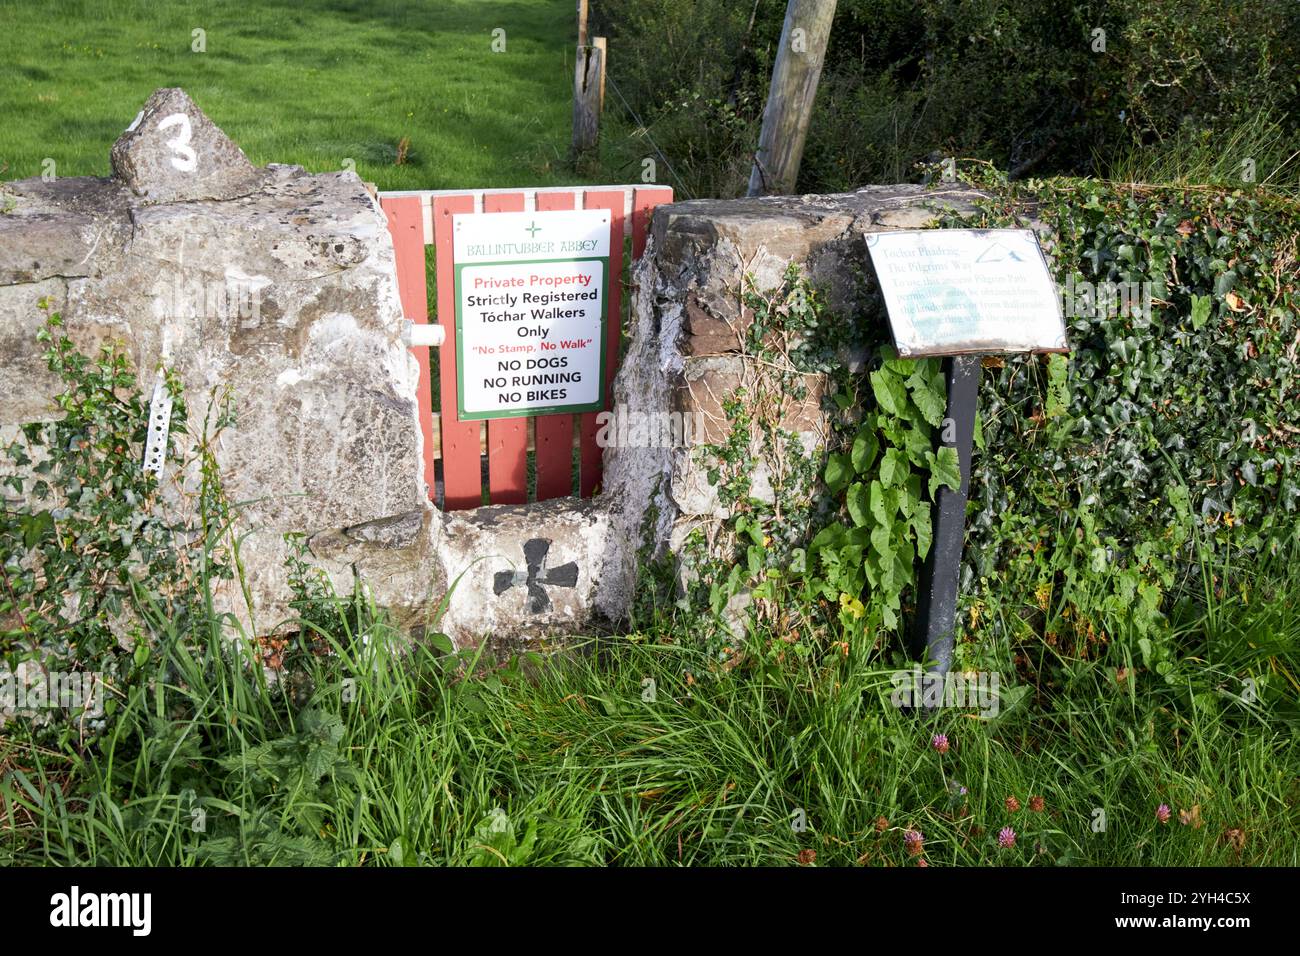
left=451, top=209, right=610, bottom=420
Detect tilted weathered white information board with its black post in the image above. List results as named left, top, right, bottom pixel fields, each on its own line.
left=867, top=229, right=1069, bottom=675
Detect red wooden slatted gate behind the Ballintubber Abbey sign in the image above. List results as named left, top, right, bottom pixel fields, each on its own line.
left=380, top=186, right=672, bottom=511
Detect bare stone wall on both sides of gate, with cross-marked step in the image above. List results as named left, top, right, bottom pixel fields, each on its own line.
left=0, top=90, right=975, bottom=646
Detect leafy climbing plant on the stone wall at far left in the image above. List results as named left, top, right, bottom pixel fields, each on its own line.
left=0, top=300, right=230, bottom=727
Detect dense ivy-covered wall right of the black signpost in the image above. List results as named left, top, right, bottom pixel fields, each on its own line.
left=945, top=181, right=1300, bottom=667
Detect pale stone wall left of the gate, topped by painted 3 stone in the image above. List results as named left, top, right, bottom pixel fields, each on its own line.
left=0, top=90, right=442, bottom=632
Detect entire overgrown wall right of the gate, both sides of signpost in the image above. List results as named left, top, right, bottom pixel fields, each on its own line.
left=624, top=181, right=1300, bottom=671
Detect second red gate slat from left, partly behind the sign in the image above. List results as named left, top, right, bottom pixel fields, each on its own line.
left=433, top=195, right=482, bottom=511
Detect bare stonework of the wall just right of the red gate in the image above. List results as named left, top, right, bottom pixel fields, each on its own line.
left=598, top=186, right=979, bottom=624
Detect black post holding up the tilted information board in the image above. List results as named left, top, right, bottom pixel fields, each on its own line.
left=911, top=355, right=980, bottom=675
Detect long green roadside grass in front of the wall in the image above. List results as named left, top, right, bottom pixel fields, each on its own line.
left=0, top=541, right=1300, bottom=866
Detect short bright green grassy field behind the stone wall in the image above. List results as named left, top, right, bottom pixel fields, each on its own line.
left=0, top=0, right=611, bottom=190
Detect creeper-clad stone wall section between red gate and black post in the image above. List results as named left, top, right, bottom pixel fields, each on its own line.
left=605, top=185, right=980, bottom=665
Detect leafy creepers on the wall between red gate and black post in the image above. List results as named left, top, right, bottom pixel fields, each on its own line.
left=688, top=265, right=959, bottom=661
